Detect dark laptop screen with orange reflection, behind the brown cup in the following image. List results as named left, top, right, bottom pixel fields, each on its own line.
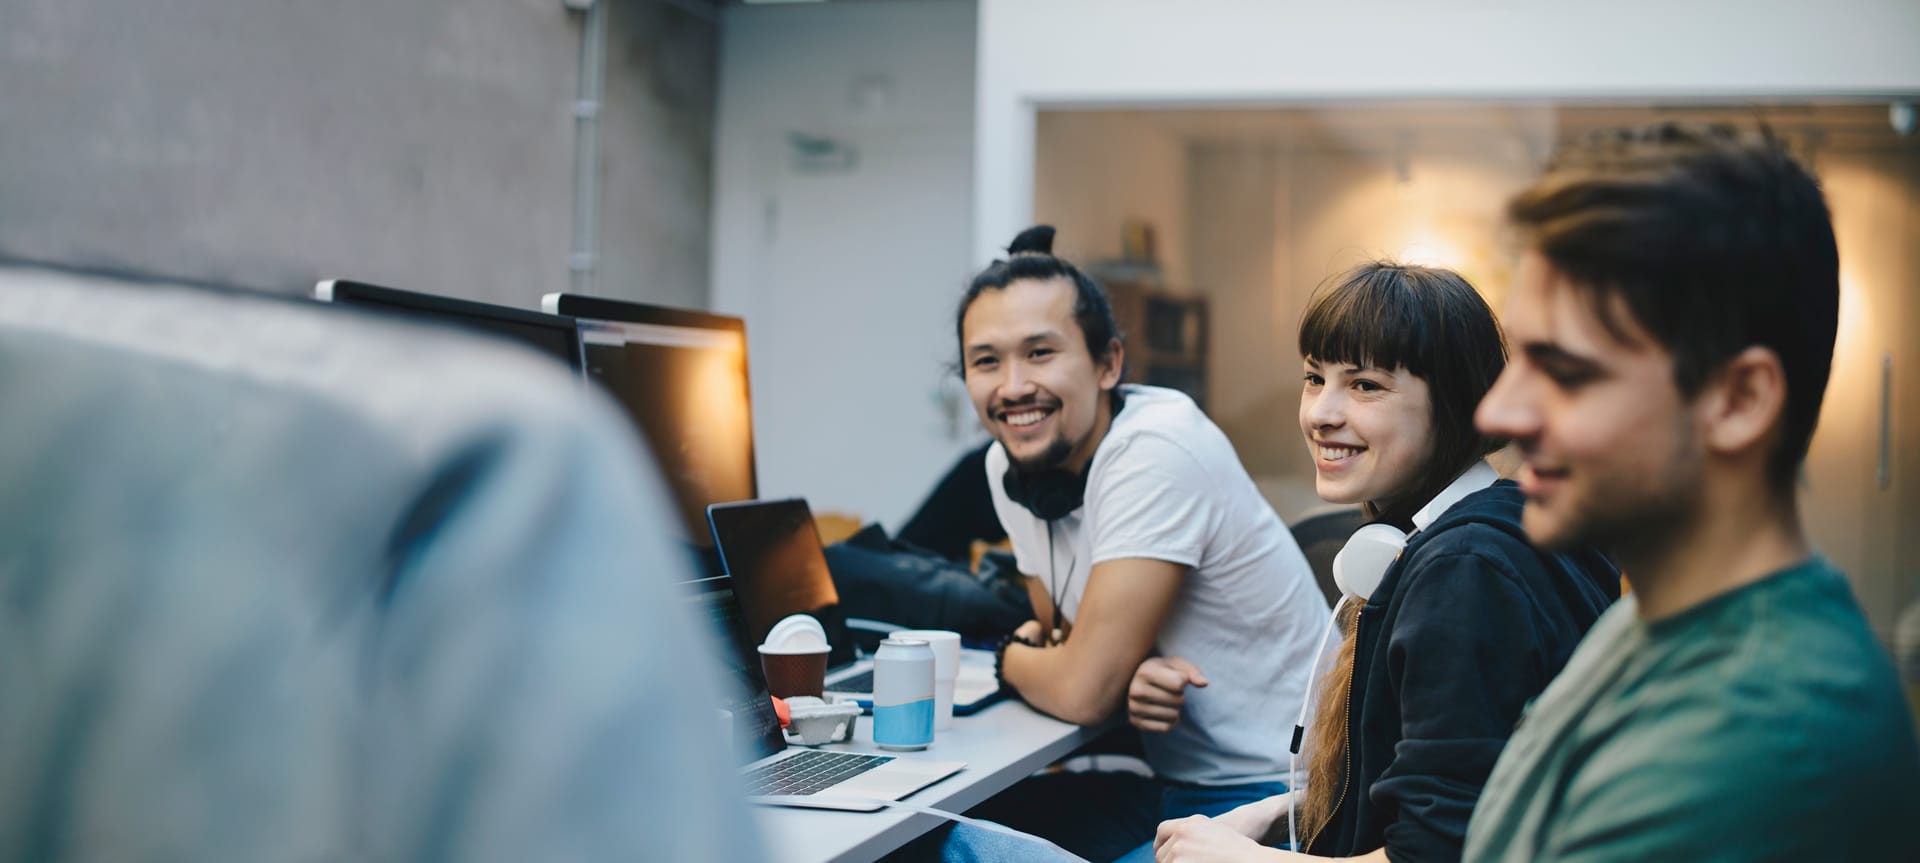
left=707, top=498, right=854, bottom=667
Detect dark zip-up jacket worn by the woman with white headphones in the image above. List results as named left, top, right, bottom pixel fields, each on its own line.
left=1308, top=481, right=1620, bottom=861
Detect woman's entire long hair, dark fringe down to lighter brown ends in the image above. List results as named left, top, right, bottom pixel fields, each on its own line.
left=1300, top=261, right=1507, bottom=848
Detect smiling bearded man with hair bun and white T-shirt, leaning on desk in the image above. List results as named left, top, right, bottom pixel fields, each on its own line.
left=936, top=227, right=1329, bottom=859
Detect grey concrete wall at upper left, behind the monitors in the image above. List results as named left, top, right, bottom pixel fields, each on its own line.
left=0, top=0, right=718, bottom=306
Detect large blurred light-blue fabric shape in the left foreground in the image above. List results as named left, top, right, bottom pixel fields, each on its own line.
left=0, top=271, right=762, bottom=861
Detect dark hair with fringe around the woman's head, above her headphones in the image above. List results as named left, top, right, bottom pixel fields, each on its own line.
left=1300, top=261, right=1507, bottom=523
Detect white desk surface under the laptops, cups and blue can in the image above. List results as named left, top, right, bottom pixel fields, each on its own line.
left=755, top=700, right=1108, bottom=863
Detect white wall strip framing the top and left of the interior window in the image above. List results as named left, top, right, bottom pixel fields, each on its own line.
left=973, top=0, right=1920, bottom=261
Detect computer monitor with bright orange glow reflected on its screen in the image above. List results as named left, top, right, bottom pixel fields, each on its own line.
left=541, top=294, right=758, bottom=557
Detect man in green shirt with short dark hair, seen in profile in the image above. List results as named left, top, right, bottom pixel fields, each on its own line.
left=1465, top=125, right=1920, bottom=863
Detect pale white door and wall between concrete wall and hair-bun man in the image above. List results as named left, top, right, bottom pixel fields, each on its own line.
left=712, top=2, right=975, bottom=527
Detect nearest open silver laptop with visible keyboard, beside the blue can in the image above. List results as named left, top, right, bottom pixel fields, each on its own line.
left=685, top=575, right=966, bottom=811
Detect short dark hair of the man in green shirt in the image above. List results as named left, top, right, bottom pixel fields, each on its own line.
left=1507, top=123, right=1839, bottom=488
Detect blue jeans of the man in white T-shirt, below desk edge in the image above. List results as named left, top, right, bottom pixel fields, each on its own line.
left=917, top=773, right=1286, bottom=863
